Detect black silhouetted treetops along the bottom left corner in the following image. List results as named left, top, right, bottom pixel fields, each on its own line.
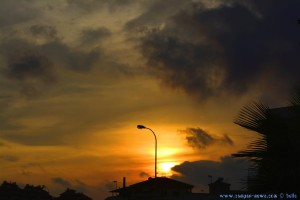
left=0, top=181, right=92, bottom=200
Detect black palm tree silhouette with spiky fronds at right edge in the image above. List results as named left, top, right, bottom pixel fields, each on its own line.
left=233, top=89, right=300, bottom=192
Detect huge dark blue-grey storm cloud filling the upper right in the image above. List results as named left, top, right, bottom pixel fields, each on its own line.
left=140, top=0, right=300, bottom=99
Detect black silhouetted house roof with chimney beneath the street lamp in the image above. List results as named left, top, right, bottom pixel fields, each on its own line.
left=106, top=177, right=240, bottom=200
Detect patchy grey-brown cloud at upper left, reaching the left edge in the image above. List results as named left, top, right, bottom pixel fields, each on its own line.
left=0, top=31, right=101, bottom=77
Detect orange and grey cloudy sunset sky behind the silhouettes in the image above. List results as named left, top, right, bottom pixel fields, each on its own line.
left=0, top=0, right=300, bottom=199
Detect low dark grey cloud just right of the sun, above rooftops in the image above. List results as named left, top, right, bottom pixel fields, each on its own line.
left=172, top=156, right=250, bottom=189
